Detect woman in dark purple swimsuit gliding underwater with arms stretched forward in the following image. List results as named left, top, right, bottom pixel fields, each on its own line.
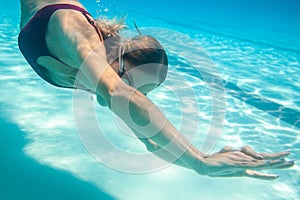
left=19, top=0, right=294, bottom=179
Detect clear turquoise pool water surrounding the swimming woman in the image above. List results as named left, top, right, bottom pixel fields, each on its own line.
left=0, top=0, right=300, bottom=200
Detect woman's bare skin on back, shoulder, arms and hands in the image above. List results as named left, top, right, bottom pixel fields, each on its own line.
left=20, top=0, right=294, bottom=179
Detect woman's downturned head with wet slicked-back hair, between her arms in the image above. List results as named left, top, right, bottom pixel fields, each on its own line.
left=118, top=35, right=168, bottom=94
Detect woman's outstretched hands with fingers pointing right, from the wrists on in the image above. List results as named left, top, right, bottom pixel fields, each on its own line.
left=199, top=146, right=295, bottom=180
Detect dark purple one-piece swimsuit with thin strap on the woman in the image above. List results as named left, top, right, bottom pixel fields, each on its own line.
left=18, top=4, right=101, bottom=87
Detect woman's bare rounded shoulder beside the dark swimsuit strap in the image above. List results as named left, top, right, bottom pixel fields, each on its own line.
left=46, top=9, right=106, bottom=67
